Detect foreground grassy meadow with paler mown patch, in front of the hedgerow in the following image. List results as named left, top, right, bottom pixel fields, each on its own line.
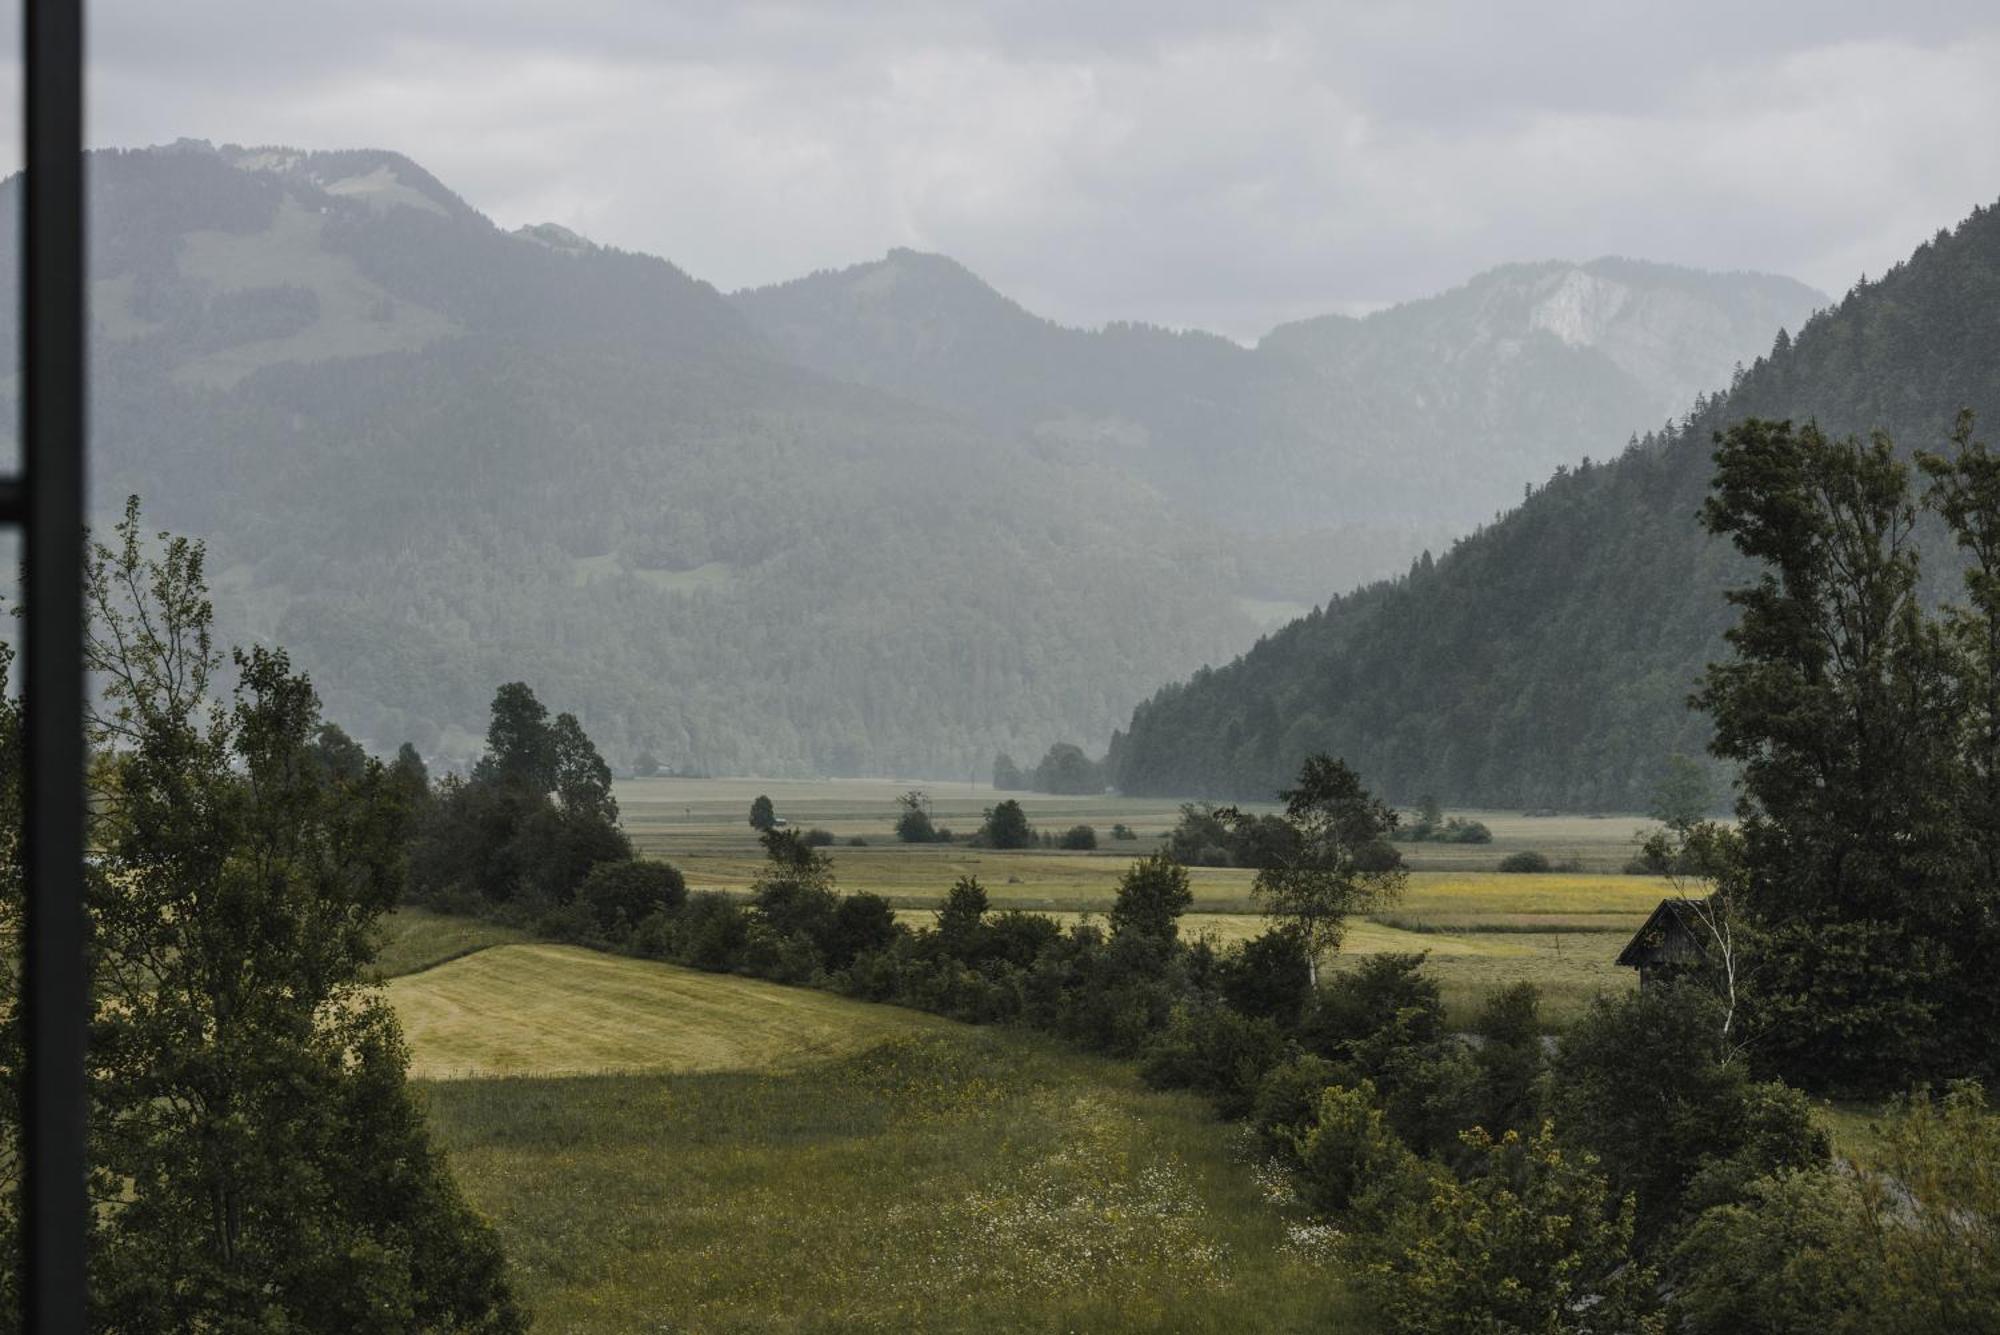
left=390, top=915, right=1362, bottom=1333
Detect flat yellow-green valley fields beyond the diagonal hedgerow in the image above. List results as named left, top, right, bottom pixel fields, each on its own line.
left=618, top=779, right=1672, bottom=1027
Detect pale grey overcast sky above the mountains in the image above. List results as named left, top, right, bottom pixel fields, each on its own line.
left=54, top=0, right=2000, bottom=338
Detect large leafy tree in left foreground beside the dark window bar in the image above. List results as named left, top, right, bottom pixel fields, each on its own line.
left=0, top=502, right=526, bottom=1335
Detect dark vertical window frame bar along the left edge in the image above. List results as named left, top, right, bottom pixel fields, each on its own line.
left=18, top=0, right=88, bottom=1335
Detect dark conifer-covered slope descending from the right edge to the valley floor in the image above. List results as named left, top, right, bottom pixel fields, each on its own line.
left=1110, top=208, right=2000, bottom=809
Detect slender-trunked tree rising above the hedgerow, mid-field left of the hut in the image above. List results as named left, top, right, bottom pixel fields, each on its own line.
left=1250, top=755, right=1404, bottom=985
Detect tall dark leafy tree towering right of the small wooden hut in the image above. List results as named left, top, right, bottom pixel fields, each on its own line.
left=1698, top=420, right=1990, bottom=1089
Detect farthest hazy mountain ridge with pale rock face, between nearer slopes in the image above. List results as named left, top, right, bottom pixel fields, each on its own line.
left=732, top=250, right=1824, bottom=547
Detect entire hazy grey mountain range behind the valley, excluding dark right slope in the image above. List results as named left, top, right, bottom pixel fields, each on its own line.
left=0, top=142, right=1818, bottom=775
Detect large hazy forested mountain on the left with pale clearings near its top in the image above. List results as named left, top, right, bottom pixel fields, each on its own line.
left=0, top=144, right=1252, bottom=773
